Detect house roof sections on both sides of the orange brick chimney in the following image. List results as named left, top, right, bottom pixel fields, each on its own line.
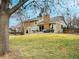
left=16, top=16, right=66, bottom=25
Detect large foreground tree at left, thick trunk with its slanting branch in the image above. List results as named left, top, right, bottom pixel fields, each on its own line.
left=0, top=0, right=28, bottom=55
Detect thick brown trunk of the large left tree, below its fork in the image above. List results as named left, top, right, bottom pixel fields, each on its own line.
left=0, top=11, right=9, bottom=55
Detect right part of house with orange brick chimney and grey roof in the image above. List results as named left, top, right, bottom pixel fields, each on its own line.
left=38, top=16, right=66, bottom=33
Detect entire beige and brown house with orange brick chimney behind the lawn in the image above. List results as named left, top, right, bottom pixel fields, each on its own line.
left=15, top=16, right=66, bottom=34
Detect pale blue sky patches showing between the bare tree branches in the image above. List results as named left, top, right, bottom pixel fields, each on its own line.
left=9, top=0, right=79, bottom=27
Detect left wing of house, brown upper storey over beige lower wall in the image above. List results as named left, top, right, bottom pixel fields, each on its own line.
left=17, top=19, right=39, bottom=34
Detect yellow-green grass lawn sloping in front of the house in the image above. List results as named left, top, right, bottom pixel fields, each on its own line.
left=10, top=33, right=79, bottom=59
